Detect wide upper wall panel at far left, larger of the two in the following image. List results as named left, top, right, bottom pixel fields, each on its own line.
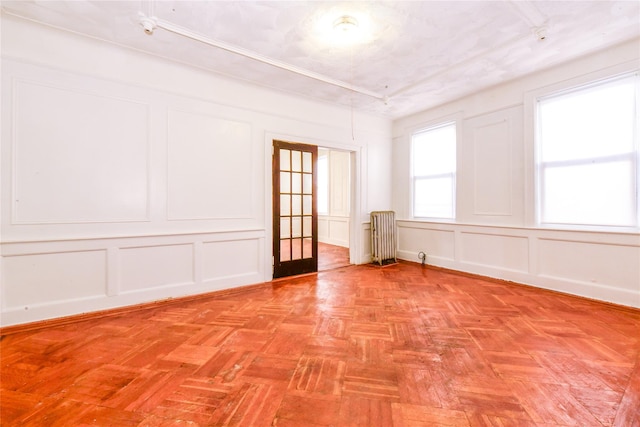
left=11, top=78, right=150, bottom=225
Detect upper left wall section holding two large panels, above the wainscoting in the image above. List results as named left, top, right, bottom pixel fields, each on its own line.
left=1, top=58, right=270, bottom=242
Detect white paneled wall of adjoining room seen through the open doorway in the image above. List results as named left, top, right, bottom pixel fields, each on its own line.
left=318, top=149, right=351, bottom=247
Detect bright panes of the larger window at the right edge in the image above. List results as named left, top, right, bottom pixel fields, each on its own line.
left=536, top=74, right=640, bottom=227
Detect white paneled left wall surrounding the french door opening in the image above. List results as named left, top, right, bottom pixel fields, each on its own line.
left=0, top=15, right=391, bottom=326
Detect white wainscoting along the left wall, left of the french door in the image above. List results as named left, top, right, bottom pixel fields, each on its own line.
left=0, top=230, right=265, bottom=326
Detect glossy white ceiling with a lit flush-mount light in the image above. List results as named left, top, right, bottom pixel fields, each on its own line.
left=2, top=0, right=640, bottom=118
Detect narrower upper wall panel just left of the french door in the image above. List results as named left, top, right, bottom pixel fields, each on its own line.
left=167, top=108, right=255, bottom=221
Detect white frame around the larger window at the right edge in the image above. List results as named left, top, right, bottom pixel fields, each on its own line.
left=525, top=70, right=640, bottom=233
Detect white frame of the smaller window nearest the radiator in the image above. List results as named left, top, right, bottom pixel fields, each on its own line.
left=409, top=120, right=460, bottom=222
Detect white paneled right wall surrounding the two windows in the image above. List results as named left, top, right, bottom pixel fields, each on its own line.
left=393, top=40, right=640, bottom=307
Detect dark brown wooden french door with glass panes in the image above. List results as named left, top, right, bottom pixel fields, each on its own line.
left=273, top=141, right=318, bottom=278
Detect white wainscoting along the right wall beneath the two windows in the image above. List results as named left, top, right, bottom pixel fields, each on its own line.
left=397, top=220, right=640, bottom=307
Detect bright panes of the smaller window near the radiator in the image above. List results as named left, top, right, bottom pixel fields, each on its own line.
left=411, top=123, right=456, bottom=218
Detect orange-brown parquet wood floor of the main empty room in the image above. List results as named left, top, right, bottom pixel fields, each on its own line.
left=0, top=262, right=640, bottom=427
